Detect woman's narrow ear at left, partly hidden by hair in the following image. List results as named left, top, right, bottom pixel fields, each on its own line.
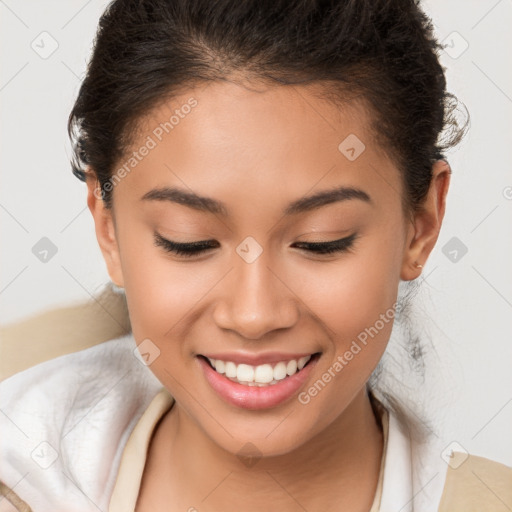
left=86, top=170, right=124, bottom=287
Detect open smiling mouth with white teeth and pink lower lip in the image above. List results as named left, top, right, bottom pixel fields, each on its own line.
left=196, top=352, right=321, bottom=409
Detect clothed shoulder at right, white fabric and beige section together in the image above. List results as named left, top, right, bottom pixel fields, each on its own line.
left=379, top=400, right=512, bottom=512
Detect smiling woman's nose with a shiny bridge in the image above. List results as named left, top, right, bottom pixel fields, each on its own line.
left=214, top=251, right=300, bottom=340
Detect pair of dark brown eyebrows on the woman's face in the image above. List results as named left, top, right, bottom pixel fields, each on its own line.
left=141, top=187, right=372, bottom=217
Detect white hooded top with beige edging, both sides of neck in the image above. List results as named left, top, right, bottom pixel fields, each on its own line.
left=0, top=334, right=447, bottom=512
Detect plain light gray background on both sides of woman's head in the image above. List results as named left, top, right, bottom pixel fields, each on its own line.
left=0, top=0, right=512, bottom=465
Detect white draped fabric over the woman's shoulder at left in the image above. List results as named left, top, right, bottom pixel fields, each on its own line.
left=0, top=334, right=162, bottom=512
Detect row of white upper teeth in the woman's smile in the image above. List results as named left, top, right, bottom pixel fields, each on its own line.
left=208, top=356, right=311, bottom=387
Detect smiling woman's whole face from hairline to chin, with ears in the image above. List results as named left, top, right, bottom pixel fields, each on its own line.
left=89, top=83, right=445, bottom=455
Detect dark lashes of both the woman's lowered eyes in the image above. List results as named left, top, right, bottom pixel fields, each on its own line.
left=155, top=233, right=357, bottom=258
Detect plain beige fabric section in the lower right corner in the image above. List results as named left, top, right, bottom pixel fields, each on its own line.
left=439, top=452, right=512, bottom=512
